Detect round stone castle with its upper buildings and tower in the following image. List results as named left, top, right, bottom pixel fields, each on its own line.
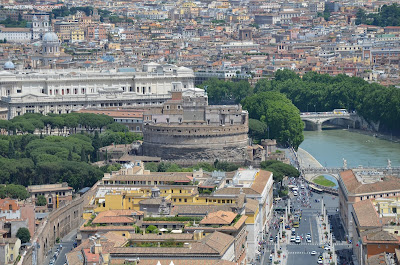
left=143, top=83, right=248, bottom=163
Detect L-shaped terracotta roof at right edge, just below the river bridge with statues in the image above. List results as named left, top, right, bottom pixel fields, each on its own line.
left=340, top=170, right=400, bottom=194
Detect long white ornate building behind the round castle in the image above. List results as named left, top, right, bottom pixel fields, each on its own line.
left=0, top=63, right=194, bottom=119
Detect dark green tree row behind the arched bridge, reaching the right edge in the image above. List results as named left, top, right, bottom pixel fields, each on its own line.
left=255, top=70, right=400, bottom=132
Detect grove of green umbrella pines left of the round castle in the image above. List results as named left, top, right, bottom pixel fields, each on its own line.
left=0, top=113, right=141, bottom=191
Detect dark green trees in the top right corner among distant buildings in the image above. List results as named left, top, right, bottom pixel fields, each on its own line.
left=355, top=3, right=400, bottom=27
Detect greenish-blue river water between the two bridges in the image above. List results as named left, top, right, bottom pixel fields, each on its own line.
left=300, top=129, right=400, bottom=168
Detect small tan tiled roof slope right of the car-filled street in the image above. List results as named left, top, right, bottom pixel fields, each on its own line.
left=353, top=200, right=381, bottom=227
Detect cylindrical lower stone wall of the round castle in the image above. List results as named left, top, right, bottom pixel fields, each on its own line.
left=143, top=124, right=248, bottom=162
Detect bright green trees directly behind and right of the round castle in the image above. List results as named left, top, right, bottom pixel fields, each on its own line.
left=201, top=75, right=304, bottom=148
